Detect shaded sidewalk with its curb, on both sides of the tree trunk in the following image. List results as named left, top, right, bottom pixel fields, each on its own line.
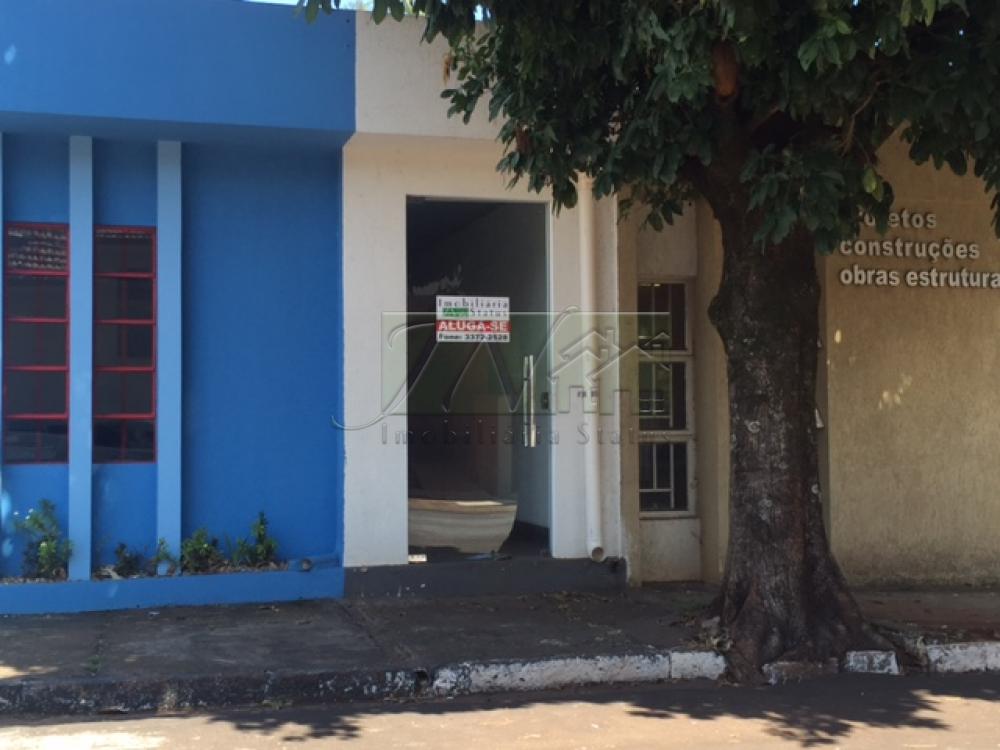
left=0, top=585, right=1000, bottom=714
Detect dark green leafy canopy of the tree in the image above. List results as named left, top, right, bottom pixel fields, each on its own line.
left=302, top=0, right=1000, bottom=250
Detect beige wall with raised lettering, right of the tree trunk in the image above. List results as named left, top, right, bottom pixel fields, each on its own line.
left=824, top=138, right=1000, bottom=583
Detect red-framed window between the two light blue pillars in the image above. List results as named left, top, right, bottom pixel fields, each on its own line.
left=94, top=227, right=156, bottom=463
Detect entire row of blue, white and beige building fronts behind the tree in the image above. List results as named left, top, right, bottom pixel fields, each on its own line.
left=0, top=0, right=1000, bottom=613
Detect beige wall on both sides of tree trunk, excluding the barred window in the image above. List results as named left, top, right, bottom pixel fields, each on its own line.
left=619, top=142, right=1000, bottom=584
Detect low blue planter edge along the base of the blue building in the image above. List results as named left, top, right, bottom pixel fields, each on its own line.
left=0, top=568, right=344, bottom=615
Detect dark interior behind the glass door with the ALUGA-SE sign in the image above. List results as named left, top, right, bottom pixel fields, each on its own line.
left=406, top=198, right=550, bottom=563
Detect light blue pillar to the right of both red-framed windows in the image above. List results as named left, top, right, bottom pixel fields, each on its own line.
left=156, top=142, right=183, bottom=555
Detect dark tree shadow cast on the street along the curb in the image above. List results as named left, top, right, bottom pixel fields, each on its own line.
left=199, top=674, right=1000, bottom=748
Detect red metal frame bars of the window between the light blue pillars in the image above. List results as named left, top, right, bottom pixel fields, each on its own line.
left=91, top=226, right=158, bottom=464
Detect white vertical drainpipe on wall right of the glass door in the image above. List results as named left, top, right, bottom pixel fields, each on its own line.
left=577, top=175, right=605, bottom=562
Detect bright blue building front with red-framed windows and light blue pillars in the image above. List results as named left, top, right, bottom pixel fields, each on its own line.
left=0, top=0, right=354, bottom=611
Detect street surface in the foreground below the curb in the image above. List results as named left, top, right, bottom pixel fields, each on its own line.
left=0, top=674, right=1000, bottom=750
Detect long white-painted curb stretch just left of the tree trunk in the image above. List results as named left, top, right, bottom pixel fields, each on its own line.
left=431, top=651, right=726, bottom=696
